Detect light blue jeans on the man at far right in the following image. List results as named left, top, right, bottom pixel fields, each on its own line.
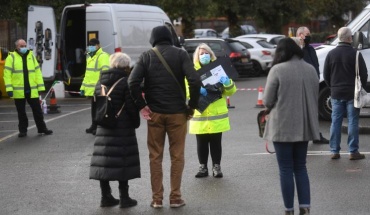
left=329, top=99, right=360, bottom=154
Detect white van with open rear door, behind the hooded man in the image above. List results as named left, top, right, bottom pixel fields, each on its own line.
left=27, top=3, right=180, bottom=95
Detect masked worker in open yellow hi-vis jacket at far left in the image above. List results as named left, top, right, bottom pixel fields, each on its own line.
left=4, top=39, right=53, bottom=137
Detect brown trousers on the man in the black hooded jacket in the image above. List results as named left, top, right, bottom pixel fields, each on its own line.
left=147, top=112, right=187, bottom=201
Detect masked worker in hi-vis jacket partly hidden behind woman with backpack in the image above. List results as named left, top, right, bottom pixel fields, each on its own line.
left=80, top=38, right=109, bottom=135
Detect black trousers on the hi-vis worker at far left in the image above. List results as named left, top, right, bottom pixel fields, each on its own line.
left=14, top=94, right=47, bottom=133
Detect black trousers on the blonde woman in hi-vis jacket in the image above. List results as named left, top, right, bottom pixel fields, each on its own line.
left=195, top=133, right=222, bottom=165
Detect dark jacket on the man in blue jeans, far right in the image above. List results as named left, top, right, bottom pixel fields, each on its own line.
left=324, top=42, right=367, bottom=100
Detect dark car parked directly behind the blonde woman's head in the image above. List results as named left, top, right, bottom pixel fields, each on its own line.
left=184, top=38, right=256, bottom=76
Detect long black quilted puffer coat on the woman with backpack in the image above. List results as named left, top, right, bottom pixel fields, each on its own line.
left=90, top=69, right=140, bottom=181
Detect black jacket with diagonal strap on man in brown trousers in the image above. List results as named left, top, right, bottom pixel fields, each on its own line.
left=128, top=41, right=200, bottom=114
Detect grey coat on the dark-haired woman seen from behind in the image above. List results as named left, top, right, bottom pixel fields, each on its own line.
left=263, top=56, right=320, bottom=142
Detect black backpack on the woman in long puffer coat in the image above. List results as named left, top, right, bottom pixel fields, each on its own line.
left=94, top=78, right=125, bottom=128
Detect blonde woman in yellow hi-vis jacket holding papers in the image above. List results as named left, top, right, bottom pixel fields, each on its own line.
left=189, top=43, right=236, bottom=178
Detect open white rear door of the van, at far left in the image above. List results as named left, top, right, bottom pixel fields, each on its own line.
left=26, top=5, right=57, bottom=81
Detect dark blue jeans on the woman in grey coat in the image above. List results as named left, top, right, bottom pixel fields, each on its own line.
left=273, top=141, right=311, bottom=211
